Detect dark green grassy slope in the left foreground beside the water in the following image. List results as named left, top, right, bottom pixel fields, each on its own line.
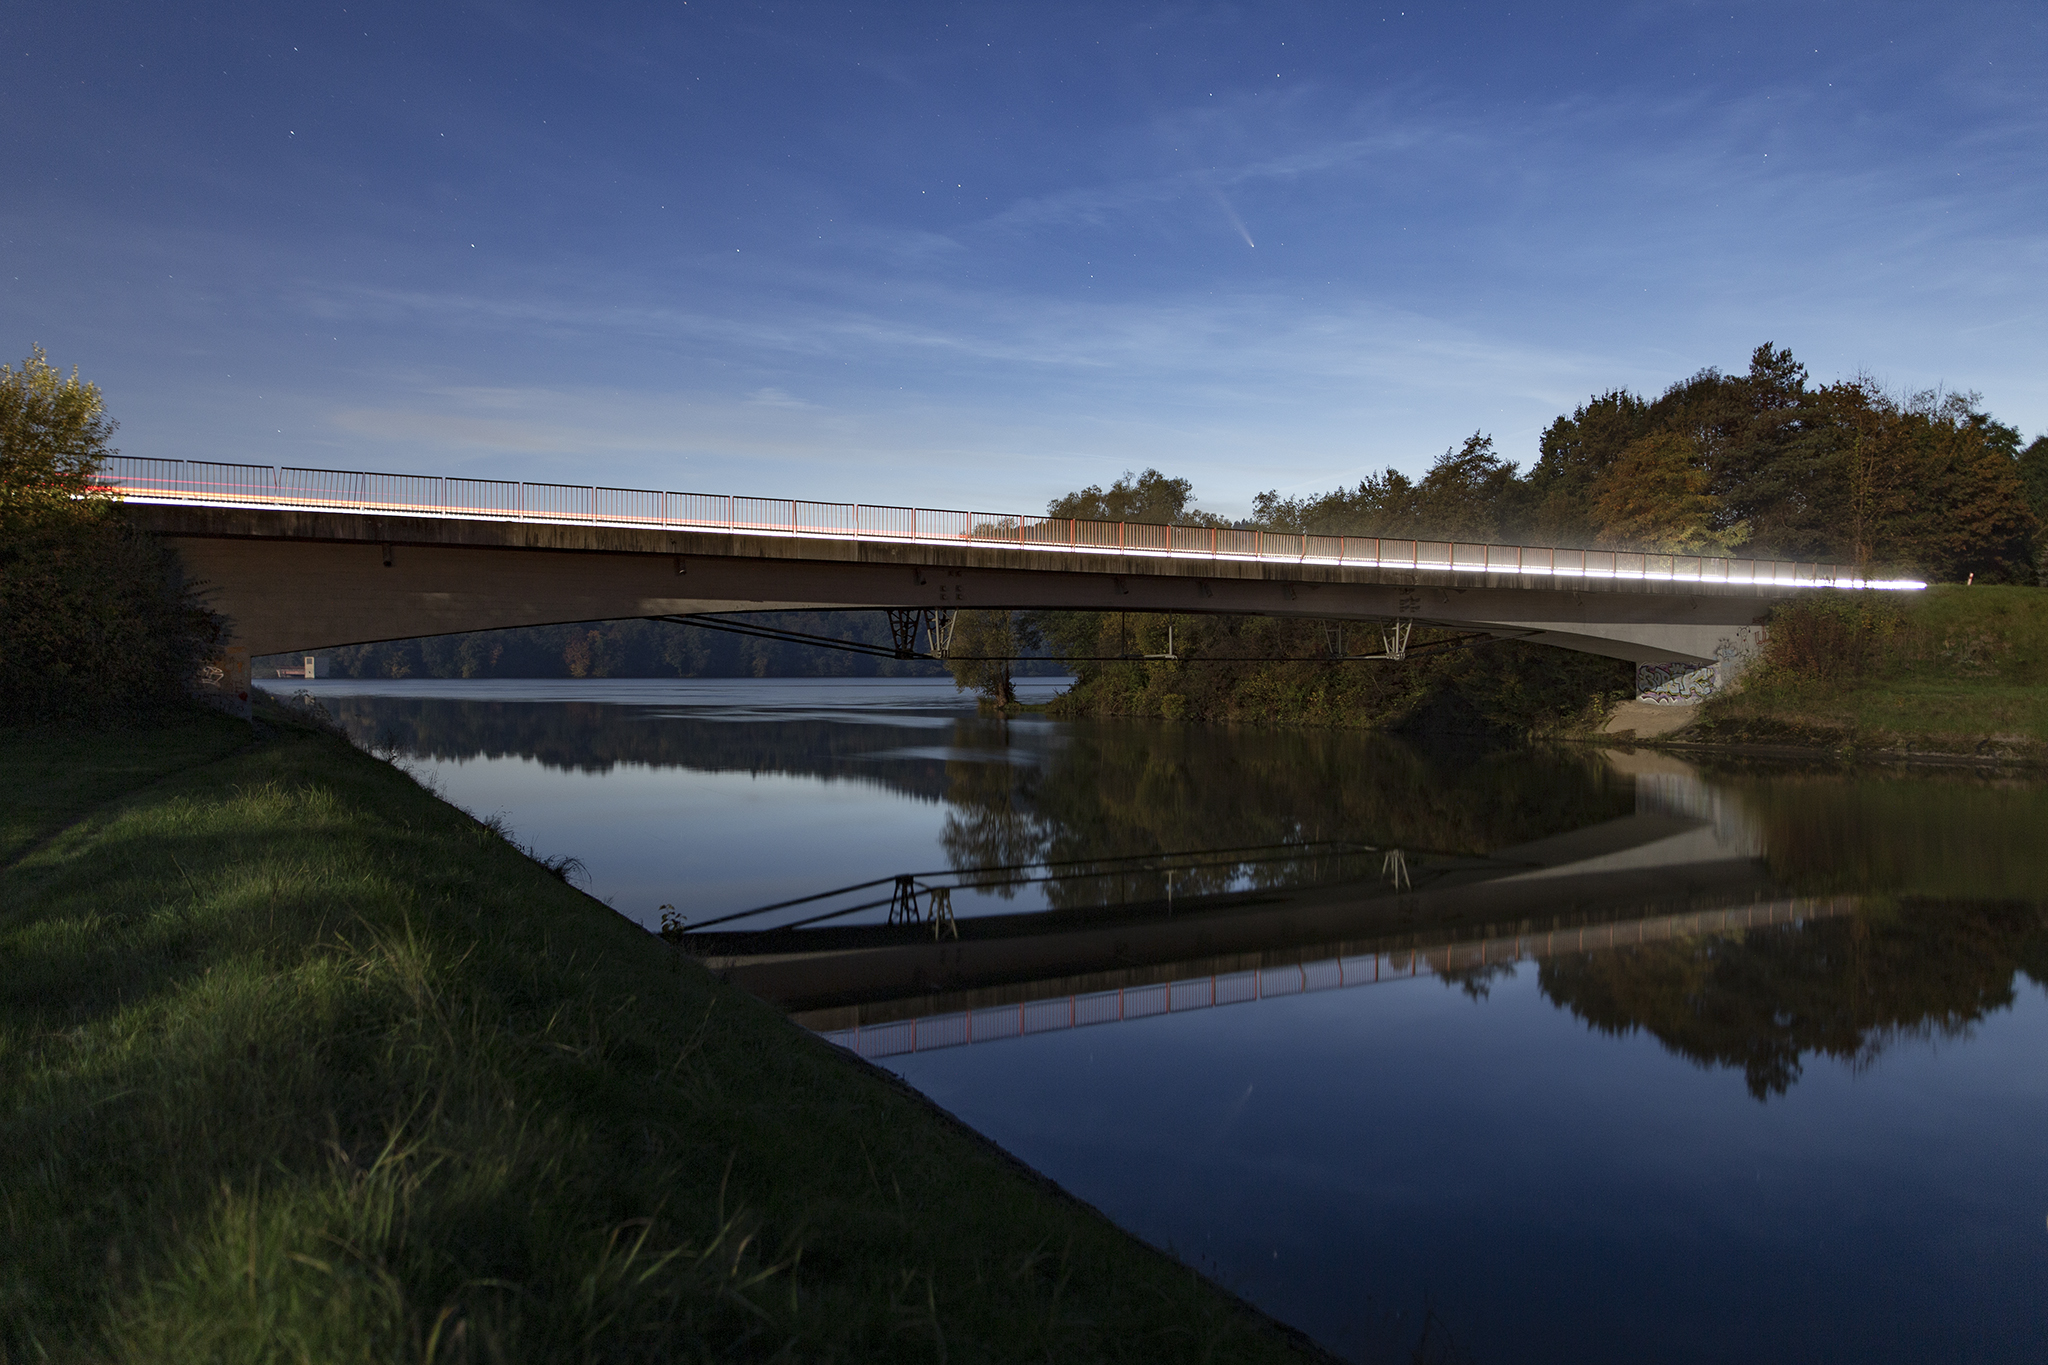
left=0, top=703, right=1313, bottom=1361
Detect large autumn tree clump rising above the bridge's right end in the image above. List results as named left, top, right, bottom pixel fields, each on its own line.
left=1255, top=344, right=2048, bottom=583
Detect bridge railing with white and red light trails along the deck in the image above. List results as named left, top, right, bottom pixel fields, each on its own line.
left=102, top=454, right=1925, bottom=587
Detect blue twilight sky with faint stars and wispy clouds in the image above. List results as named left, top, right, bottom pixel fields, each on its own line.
left=0, top=0, right=2048, bottom=512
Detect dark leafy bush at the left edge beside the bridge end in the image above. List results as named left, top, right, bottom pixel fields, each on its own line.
left=0, top=350, right=217, bottom=724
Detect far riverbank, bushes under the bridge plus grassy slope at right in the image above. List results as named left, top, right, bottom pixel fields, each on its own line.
left=1047, top=583, right=2048, bottom=763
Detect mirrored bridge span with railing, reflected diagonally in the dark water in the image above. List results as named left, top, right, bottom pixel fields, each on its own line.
left=692, top=755, right=1862, bottom=1058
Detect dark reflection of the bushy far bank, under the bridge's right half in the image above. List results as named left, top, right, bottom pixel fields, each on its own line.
left=944, top=720, right=1634, bottom=907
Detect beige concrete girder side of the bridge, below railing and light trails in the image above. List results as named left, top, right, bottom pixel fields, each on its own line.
left=144, top=503, right=1788, bottom=665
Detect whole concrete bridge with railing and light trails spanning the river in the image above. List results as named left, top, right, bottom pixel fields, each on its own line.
left=102, top=456, right=1925, bottom=690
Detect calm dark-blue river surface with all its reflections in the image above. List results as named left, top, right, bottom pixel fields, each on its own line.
left=272, top=679, right=2048, bottom=1361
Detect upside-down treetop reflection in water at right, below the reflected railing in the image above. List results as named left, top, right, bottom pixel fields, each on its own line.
left=1538, top=898, right=2048, bottom=1101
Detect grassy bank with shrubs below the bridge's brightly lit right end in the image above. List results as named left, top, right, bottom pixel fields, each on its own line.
left=1673, top=585, right=2048, bottom=761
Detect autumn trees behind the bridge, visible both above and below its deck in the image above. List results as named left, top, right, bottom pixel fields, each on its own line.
left=952, top=342, right=2048, bottom=731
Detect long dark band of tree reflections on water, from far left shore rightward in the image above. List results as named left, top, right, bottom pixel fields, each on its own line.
left=330, top=696, right=1634, bottom=907
